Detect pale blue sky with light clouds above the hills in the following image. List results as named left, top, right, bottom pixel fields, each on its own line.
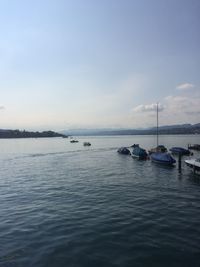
left=0, top=0, right=200, bottom=130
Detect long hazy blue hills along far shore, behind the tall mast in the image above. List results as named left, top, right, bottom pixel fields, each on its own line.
left=62, top=123, right=200, bottom=136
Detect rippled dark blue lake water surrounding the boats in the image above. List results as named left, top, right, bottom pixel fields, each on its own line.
left=0, top=135, right=200, bottom=267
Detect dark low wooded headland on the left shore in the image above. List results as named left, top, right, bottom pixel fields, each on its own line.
left=0, top=129, right=66, bottom=138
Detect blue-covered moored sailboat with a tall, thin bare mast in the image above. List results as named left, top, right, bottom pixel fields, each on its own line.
left=151, top=103, right=176, bottom=165
